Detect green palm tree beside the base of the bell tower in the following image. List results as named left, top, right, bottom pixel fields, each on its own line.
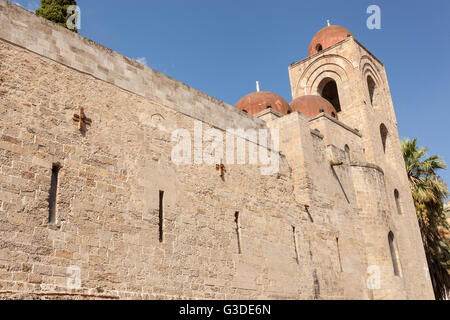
left=402, top=139, right=450, bottom=300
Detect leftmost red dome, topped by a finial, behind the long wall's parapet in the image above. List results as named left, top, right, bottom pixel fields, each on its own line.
left=236, top=91, right=291, bottom=115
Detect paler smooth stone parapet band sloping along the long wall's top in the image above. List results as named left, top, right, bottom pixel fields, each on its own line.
left=0, top=0, right=264, bottom=135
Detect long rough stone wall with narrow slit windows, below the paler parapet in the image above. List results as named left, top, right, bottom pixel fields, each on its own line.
left=0, top=41, right=326, bottom=299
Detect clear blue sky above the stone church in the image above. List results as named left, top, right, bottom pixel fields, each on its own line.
left=16, top=0, right=450, bottom=182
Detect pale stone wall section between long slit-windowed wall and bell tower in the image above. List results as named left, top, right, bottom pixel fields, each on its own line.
left=268, top=112, right=372, bottom=299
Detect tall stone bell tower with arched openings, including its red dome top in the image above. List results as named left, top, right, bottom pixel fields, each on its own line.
left=289, top=23, right=431, bottom=298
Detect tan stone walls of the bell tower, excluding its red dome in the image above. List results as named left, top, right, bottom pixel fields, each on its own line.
left=289, top=30, right=434, bottom=298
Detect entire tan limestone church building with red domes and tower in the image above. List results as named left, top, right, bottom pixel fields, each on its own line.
left=0, top=0, right=434, bottom=299
